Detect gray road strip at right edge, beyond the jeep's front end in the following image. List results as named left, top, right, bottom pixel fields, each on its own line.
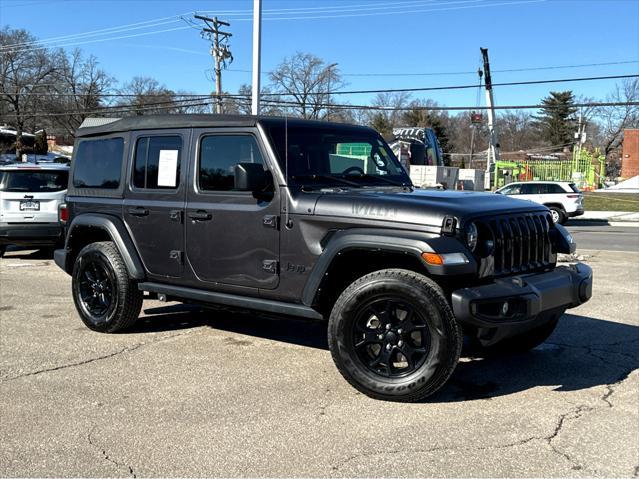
left=567, top=221, right=639, bottom=253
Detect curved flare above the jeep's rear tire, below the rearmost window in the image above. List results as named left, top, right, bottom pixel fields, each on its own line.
left=65, top=213, right=146, bottom=280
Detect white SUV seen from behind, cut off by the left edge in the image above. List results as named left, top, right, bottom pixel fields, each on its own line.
left=0, top=164, right=69, bottom=256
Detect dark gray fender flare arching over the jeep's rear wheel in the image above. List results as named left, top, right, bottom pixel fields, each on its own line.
left=64, top=213, right=146, bottom=280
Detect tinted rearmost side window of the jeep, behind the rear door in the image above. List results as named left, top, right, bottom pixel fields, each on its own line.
left=73, top=138, right=124, bottom=190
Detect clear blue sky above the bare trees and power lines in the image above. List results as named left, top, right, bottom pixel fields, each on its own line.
left=0, top=0, right=639, bottom=106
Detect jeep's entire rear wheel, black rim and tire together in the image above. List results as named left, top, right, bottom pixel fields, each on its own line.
left=72, top=241, right=142, bottom=333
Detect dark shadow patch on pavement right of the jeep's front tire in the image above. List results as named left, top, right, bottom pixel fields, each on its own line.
left=438, top=314, right=639, bottom=402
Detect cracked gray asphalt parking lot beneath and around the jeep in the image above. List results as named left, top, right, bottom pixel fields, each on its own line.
left=0, top=250, right=639, bottom=477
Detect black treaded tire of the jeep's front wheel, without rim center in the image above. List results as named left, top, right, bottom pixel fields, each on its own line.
left=328, top=269, right=462, bottom=402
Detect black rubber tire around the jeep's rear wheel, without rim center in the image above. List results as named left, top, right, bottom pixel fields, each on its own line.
left=71, top=241, right=143, bottom=333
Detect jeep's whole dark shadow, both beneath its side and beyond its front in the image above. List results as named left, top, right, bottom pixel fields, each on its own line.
left=131, top=304, right=639, bottom=402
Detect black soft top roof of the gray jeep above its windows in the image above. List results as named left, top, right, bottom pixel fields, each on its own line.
left=76, top=114, right=374, bottom=137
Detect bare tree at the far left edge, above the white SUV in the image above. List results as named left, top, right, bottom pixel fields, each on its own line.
left=0, top=27, right=63, bottom=156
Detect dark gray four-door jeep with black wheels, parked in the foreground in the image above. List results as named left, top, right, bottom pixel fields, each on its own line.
left=55, top=115, right=592, bottom=401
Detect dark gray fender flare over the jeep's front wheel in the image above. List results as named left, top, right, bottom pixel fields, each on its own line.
left=302, top=228, right=477, bottom=306
